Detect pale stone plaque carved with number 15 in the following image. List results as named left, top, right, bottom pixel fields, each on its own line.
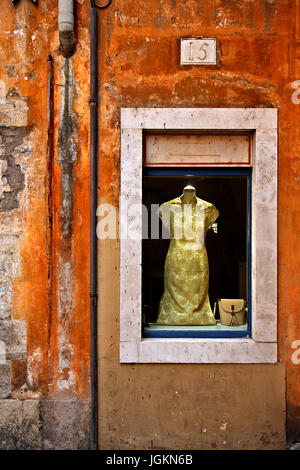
left=180, top=38, right=217, bottom=65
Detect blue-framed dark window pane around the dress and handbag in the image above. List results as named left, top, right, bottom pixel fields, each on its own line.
left=142, top=167, right=251, bottom=338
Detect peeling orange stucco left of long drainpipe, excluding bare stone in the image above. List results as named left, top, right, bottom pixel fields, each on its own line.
left=0, top=0, right=89, bottom=398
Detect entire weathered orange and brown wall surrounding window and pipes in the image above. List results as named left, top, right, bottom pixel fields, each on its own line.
left=0, top=0, right=300, bottom=449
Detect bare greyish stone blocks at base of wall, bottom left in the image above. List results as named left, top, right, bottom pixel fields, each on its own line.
left=0, top=398, right=90, bottom=450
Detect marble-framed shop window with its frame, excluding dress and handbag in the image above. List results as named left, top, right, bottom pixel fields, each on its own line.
left=120, top=108, right=277, bottom=363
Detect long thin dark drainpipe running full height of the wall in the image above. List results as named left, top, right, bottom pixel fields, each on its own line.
left=89, top=0, right=112, bottom=450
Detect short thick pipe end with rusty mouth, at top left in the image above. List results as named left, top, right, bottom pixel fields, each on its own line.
left=58, top=0, right=76, bottom=58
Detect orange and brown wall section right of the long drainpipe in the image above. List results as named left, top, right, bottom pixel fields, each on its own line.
left=99, top=0, right=300, bottom=449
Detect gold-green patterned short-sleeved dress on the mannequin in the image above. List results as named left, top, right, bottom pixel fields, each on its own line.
left=157, top=196, right=219, bottom=326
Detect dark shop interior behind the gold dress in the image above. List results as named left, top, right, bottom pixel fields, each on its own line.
left=142, top=169, right=249, bottom=325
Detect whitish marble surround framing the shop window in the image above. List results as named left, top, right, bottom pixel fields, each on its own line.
left=120, top=108, right=277, bottom=364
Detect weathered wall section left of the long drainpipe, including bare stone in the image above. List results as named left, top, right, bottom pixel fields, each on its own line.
left=0, top=0, right=89, bottom=449
